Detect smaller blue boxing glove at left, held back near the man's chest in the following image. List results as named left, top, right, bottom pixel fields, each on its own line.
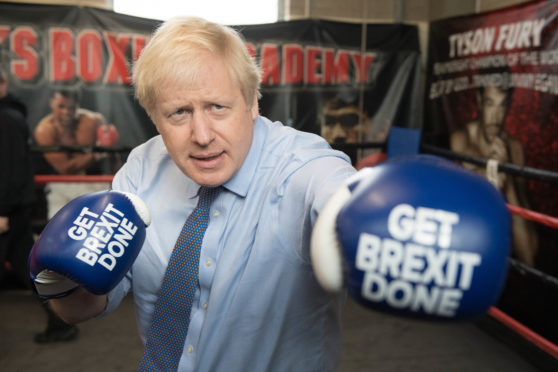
left=29, top=191, right=150, bottom=299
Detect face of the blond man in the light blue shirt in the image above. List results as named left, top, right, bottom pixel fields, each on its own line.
left=151, top=56, right=258, bottom=186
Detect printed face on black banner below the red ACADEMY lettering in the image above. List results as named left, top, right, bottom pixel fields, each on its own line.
left=321, top=106, right=362, bottom=143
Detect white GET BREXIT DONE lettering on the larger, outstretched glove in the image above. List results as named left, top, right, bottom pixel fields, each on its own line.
left=355, top=204, right=482, bottom=317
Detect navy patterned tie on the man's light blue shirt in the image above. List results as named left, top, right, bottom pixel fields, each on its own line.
left=139, top=187, right=219, bottom=371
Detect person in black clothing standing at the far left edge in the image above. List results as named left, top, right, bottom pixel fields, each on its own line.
left=0, top=66, right=35, bottom=288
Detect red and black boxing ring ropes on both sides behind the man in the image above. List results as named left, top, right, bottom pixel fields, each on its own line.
left=32, top=142, right=558, bottom=361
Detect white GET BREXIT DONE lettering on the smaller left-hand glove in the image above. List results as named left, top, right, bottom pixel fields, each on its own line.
left=68, top=203, right=138, bottom=271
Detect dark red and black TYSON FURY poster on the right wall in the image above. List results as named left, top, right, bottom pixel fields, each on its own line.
left=423, top=1, right=558, bottom=343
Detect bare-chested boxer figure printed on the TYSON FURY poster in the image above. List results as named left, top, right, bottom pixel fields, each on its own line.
left=450, top=86, right=538, bottom=266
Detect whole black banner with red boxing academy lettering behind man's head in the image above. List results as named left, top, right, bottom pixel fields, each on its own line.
left=0, top=3, right=420, bottom=166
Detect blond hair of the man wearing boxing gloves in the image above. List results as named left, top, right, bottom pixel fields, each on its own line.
left=132, top=17, right=261, bottom=114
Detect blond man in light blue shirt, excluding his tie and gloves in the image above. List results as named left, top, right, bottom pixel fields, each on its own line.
left=46, top=18, right=355, bottom=371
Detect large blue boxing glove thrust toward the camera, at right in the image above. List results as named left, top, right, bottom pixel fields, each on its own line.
left=311, top=155, right=511, bottom=320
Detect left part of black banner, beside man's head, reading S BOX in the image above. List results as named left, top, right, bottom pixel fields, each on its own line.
left=0, top=3, right=161, bottom=146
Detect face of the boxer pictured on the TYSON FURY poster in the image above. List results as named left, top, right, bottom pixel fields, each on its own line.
left=480, top=86, right=509, bottom=140
